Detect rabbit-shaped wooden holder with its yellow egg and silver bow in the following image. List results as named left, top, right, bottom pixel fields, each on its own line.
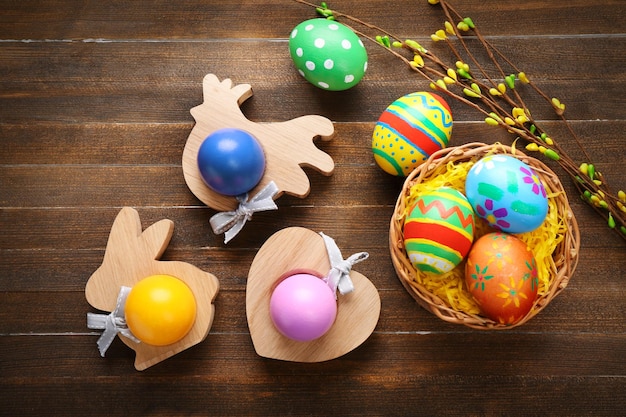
left=85, top=207, right=219, bottom=370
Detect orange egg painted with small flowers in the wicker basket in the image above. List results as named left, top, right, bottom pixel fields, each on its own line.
left=465, top=232, right=539, bottom=324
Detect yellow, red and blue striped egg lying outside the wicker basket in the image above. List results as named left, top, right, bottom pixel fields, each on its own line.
left=372, top=92, right=452, bottom=176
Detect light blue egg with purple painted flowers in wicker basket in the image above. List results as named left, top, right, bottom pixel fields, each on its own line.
left=465, top=155, right=548, bottom=233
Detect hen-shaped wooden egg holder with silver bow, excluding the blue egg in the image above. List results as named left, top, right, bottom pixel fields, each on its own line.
left=182, top=74, right=334, bottom=241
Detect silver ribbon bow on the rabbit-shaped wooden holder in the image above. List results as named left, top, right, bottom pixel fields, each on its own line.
left=87, top=287, right=139, bottom=357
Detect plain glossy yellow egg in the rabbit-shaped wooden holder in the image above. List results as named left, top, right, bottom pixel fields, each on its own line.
left=124, top=275, right=196, bottom=346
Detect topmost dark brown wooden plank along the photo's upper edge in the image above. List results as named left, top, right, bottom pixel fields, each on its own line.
left=0, top=0, right=621, bottom=40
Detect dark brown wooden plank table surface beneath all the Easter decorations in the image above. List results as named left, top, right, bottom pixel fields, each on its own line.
left=0, top=0, right=626, bottom=416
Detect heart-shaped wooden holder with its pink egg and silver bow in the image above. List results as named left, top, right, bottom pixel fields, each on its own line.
left=246, top=227, right=380, bottom=362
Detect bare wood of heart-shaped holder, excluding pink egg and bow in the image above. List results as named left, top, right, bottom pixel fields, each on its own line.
left=246, top=227, right=380, bottom=362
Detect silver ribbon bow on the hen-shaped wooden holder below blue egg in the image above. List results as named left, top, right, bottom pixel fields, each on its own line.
left=209, top=181, right=279, bottom=243
